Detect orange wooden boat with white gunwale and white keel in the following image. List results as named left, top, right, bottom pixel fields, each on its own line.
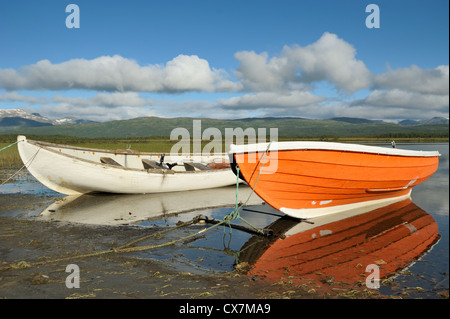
left=229, top=142, right=440, bottom=218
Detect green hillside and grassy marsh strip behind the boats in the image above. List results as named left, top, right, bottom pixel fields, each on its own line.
left=0, top=117, right=449, bottom=168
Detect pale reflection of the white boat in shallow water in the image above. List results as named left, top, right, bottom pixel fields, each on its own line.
left=40, top=186, right=263, bottom=225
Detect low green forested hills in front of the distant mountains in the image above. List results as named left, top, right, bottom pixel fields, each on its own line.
left=0, top=117, right=449, bottom=138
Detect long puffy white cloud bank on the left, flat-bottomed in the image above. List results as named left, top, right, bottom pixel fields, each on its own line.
left=0, top=55, right=239, bottom=92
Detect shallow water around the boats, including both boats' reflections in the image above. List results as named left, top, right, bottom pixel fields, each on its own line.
left=0, top=144, right=449, bottom=298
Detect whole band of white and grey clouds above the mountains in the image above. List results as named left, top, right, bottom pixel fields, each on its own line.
left=0, top=32, right=449, bottom=120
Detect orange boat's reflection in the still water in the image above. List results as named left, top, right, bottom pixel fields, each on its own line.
left=239, top=199, right=439, bottom=284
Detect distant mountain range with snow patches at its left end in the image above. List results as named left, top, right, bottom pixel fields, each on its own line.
left=0, top=109, right=449, bottom=137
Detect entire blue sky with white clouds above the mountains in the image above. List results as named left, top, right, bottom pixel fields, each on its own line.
left=0, top=0, right=449, bottom=121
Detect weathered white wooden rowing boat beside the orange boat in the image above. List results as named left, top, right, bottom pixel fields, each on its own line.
left=17, top=135, right=236, bottom=195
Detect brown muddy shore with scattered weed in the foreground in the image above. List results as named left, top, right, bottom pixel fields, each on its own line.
left=0, top=195, right=382, bottom=300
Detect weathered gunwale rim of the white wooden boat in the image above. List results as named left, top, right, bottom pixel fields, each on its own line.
left=22, top=139, right=227, bottom=175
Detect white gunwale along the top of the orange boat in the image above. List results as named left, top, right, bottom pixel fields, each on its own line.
left=229, top=141, right=441, bottom=157
